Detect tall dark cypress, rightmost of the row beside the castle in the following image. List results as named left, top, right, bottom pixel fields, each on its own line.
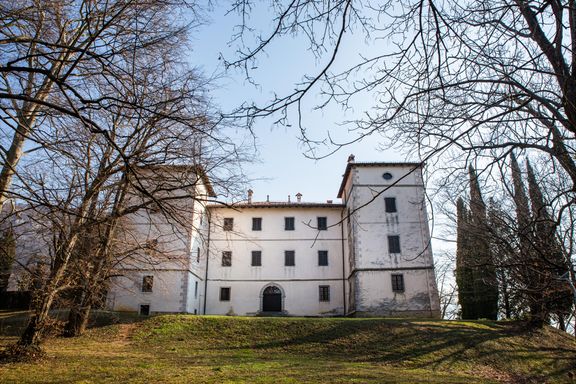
left=526, top=160, right=573, bottom=330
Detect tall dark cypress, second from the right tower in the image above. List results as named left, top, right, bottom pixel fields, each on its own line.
left=469, top=165, right=498, bottom=320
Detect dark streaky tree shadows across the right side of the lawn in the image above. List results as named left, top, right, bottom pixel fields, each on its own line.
left=213, top=320, right=576, bottom=381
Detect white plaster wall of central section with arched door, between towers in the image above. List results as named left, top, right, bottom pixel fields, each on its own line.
left=207, top=206, right=347, bottom=316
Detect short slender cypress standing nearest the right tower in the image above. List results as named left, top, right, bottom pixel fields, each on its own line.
left=456, top=197, right=478, bottom=320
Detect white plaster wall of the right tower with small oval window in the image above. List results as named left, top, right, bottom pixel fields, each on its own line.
left=347, top=164, right=439, bottom=316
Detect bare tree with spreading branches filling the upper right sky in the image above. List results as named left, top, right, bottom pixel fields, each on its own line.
left=227, top=0, right=576, bottom=177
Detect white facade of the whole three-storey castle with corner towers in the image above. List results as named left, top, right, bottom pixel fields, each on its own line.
left=108, top=162, right=439, bottom=317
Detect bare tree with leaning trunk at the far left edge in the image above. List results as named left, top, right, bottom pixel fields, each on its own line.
left=0, top=0, right=207, bottom=210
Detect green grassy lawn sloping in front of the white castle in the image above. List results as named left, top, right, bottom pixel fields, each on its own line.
left=0, top=312, right=576, bottom=384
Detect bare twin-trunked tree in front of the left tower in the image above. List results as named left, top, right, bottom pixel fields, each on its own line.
left=0, top=1, right=252, bottom=353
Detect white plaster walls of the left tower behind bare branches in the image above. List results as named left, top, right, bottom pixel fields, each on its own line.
left=107, top=174, right=208, bottom=313
